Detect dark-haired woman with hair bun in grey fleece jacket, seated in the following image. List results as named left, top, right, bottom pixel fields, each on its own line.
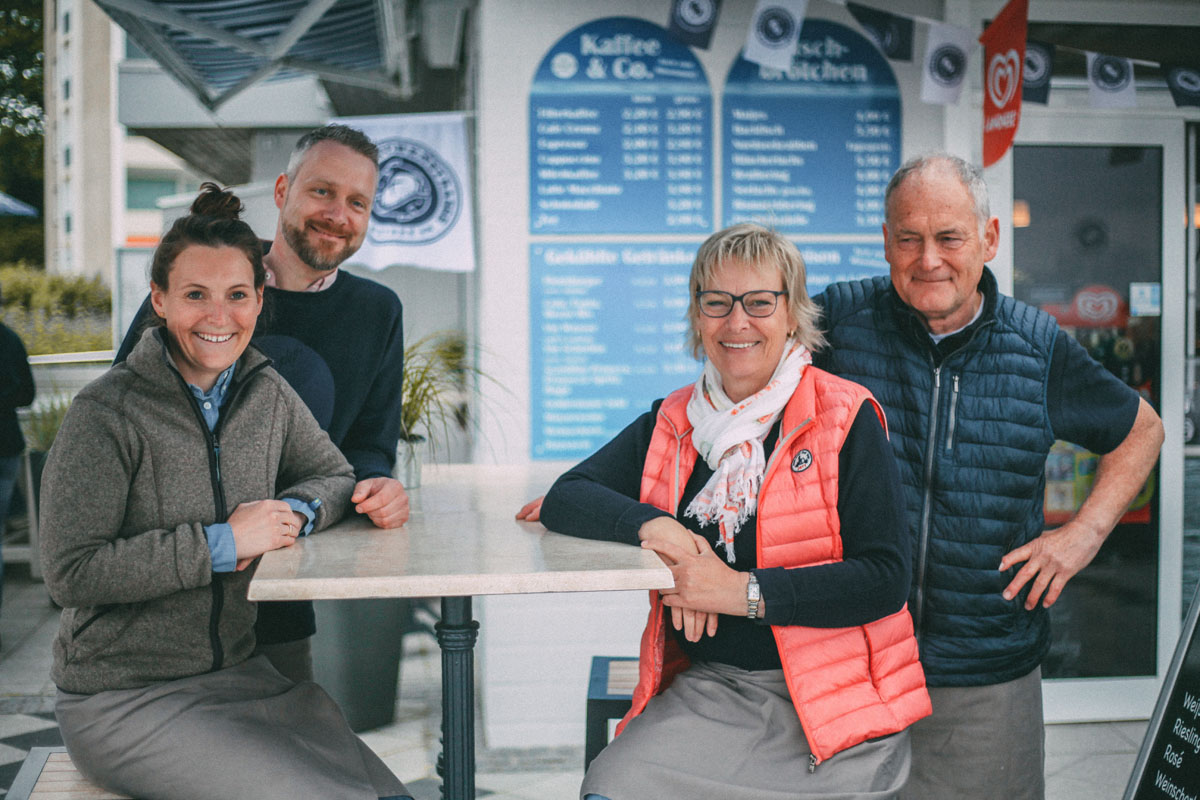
left=41, top=184, right=408, bottom=800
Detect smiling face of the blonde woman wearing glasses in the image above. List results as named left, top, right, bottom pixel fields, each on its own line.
left=695, top=261, right=792, bottom=403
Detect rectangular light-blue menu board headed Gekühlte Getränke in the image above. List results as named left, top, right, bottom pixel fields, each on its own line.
left=529, top=242, right=701, bottom=459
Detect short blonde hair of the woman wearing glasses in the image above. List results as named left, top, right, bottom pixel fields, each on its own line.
left=688, top=222, right=826, bottom=359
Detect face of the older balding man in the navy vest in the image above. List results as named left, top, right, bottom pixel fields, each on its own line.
left=883, top=163, right=1000, bottom=333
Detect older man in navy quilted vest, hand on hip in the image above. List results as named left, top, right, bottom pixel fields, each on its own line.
left=816, top=155, right=1163, bottom=800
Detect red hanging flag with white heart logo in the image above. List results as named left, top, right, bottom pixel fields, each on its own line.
left=979, top=0, right=1030, bottom=167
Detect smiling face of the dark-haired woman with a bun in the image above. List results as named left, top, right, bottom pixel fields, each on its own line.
left=150, top=245, right=263, bottom=391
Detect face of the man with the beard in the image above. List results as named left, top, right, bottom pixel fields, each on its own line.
left=275, top=142, right=378, bottom=272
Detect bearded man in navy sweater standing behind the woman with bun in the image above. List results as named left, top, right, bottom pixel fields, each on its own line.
left=116, top=125, right=408, bottom=681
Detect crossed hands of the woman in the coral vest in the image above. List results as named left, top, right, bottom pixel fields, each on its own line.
left=642, top=534, right=761, bottom=628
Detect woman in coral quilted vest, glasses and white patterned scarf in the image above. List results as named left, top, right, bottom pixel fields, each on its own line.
left=541, top=224, right=930, bottom=800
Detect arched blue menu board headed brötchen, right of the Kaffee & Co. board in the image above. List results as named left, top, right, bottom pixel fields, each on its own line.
left=721, top=19, right=900, bottom=288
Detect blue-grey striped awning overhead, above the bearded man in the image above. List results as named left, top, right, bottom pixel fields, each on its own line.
left=96, top=0, right=413, bottom=110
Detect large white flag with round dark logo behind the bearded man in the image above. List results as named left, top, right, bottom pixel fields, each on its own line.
left=330, top=113, right=475, bottom=272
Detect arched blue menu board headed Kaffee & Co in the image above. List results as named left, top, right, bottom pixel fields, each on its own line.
left=529, top=17, right=713, bottom=234
